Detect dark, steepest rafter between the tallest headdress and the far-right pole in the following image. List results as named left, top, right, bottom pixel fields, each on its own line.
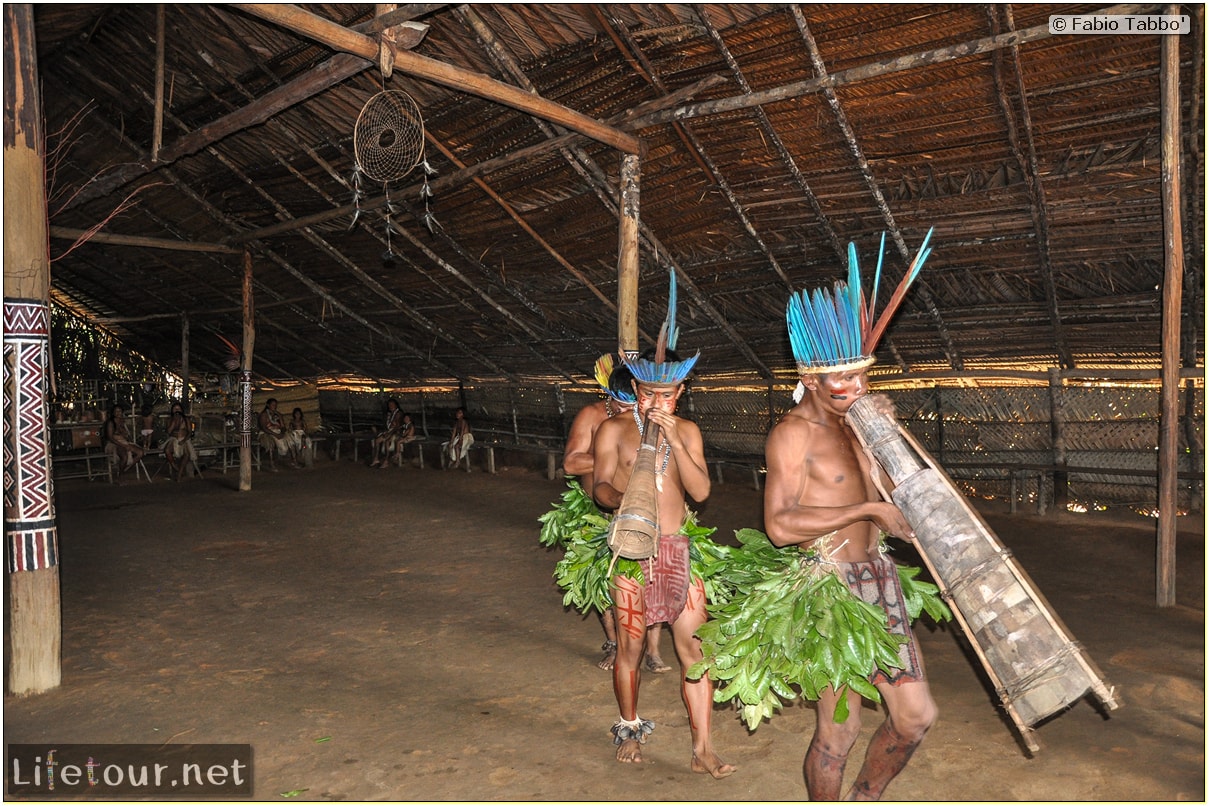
left=987, top=5, right=1075, bottom=370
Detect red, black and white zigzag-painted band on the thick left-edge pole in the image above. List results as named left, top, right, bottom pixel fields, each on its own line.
left=4, top=298, right=58, bottom=573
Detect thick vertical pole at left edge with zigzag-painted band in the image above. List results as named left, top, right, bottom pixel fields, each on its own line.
left=4, top=4, right=63, bottom=695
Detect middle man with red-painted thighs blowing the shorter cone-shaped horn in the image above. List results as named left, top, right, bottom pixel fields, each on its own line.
left=592, top=273, right=735, bottom=778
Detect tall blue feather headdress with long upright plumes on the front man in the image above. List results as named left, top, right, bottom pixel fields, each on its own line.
left=785, top=227, right=935, bottom=373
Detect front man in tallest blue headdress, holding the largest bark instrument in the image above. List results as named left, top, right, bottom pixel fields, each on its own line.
left=764, top=232, right=937, bottom=800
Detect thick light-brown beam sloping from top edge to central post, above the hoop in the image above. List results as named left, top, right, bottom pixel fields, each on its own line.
left=232, top=2, right=643, bottom=155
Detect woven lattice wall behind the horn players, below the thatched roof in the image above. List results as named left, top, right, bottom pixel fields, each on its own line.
left=319, top=382, right=1204, bottom=511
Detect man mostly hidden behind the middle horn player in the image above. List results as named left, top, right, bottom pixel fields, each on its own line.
left=562, top=353, right=672, bottom=674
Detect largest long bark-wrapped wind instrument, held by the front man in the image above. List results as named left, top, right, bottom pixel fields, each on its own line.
left=848, top=398, right=1118, bottom=750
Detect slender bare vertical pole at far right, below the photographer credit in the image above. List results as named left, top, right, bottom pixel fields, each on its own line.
left=1156, top=14, right=1184, bottom=608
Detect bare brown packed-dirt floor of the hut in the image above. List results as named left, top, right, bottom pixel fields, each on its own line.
left=4, top=458, right=1205, bottom=801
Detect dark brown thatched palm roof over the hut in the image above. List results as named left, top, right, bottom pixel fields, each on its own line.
left=25, top=4, right=1204, bottom=383
